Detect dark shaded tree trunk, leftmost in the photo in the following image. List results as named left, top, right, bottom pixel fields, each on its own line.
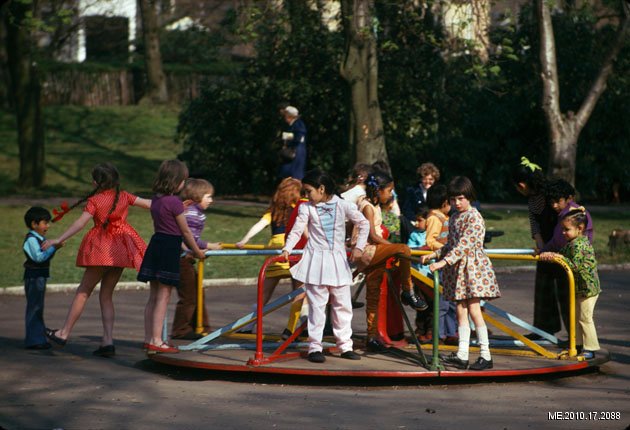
left=5, top=1, right=46, bottom=188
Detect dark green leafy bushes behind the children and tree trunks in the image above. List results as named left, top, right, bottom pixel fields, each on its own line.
left=179, top=2, right=630, bottom=201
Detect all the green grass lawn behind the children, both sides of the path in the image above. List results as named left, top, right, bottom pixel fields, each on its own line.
left=0, top=106, right=630, bottom=287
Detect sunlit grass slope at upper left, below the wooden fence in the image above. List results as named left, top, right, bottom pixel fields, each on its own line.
left=0, top=106, right=181, bottom=197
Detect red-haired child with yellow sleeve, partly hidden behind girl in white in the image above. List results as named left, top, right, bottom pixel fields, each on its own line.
left=236, top=178, right=302, bottom=332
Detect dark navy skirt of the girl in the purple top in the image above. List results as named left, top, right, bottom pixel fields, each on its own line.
left=138, top=233, right=182, bottom=287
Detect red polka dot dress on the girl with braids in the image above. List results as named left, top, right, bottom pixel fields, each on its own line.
left=77, top=189, right=147, bottom=270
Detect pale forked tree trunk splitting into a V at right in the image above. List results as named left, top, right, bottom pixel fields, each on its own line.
left=536, top=0, right=630, bottom=184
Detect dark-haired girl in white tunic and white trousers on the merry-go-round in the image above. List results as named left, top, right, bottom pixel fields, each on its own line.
left=282, top=170, right=369, bottom=363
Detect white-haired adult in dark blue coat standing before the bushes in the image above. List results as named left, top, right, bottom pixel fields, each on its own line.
left=278, top=106, right=306, bottom=180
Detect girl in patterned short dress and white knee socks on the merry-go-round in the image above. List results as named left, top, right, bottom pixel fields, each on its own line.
left=422, top=176, right=501, bottom=370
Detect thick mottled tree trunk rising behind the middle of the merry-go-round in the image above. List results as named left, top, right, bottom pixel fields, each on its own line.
left=340, top=0, right=388, bottom=164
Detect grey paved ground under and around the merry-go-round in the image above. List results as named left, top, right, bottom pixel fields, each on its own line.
left=0, top=270, right=630, bottom=430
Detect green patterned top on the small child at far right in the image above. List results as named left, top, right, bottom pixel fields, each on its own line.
left=560, top=236, right=601, bottom=297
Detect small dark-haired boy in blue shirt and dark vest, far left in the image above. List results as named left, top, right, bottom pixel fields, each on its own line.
left=22, top=206, right=63, bottom=349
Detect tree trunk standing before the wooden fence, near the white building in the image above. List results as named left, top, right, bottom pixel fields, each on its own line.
left=138, top=0, right=168, bottom=104
